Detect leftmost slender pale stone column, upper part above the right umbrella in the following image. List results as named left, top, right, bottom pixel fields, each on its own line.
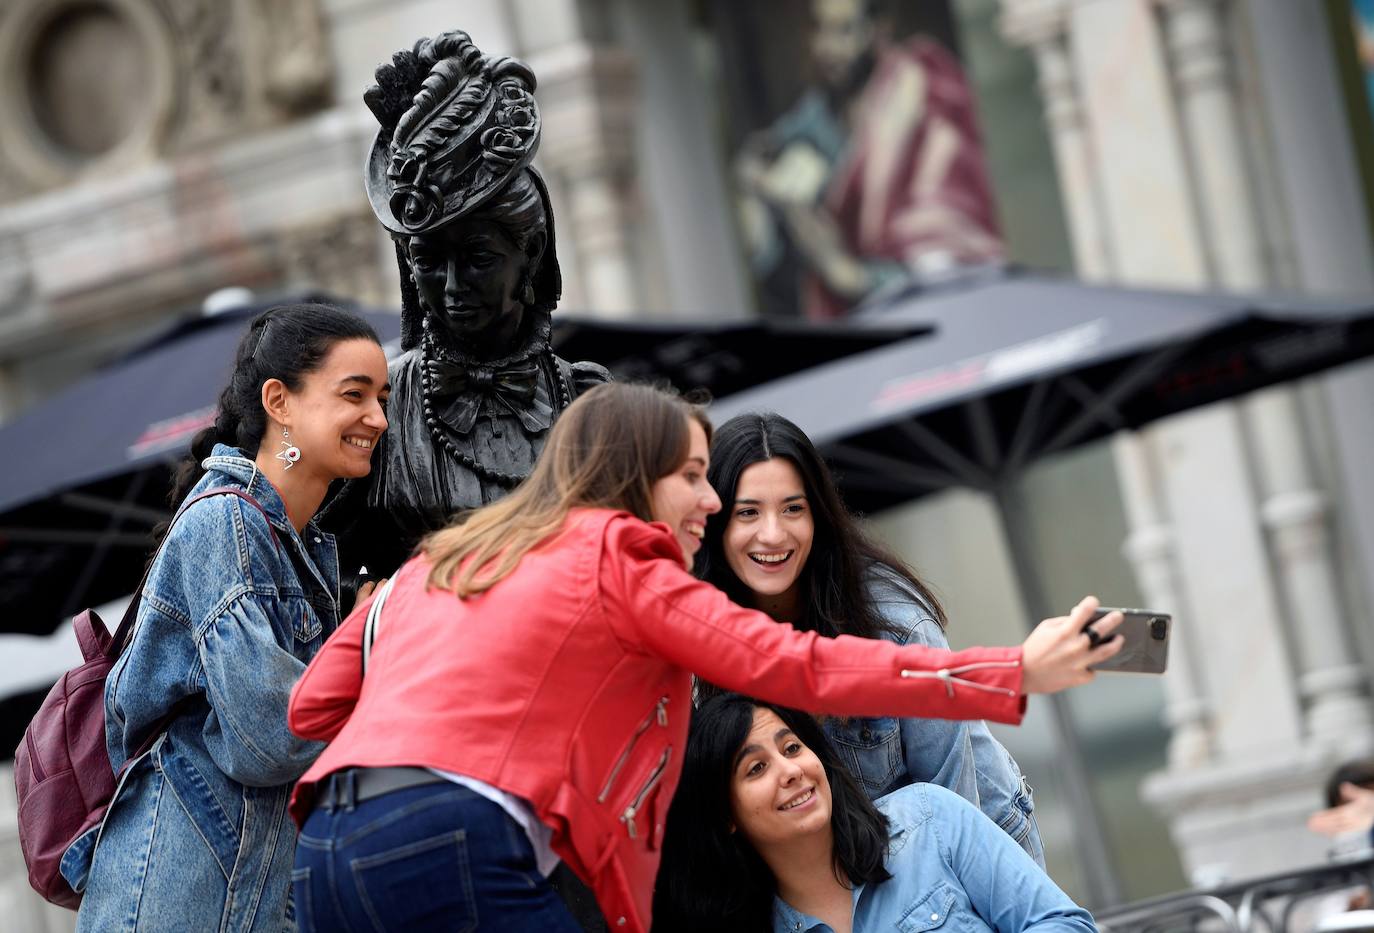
left=1002, top=0, right=1114, bottom=280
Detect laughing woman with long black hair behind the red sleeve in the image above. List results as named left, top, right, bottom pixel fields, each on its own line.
left=698, top=414, right=1044, bottom=867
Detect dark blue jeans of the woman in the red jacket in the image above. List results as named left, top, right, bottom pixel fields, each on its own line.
left=291, top=782, right=580, bottom=933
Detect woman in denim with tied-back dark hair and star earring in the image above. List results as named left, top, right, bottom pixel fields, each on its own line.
left=62, top=305, right=387, bottom=933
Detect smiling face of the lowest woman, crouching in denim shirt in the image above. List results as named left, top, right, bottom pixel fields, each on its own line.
left=730, top=706, right=831, bottom=862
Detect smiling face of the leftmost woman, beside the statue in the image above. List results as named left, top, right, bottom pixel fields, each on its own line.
left=277, top=339, right=392, bottom=481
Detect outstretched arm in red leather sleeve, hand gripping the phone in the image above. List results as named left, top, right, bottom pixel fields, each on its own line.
left=600, top=517, right=1120, bottom=723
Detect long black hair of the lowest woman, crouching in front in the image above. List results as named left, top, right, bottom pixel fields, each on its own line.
left=654, top=694, right=892, bottom=933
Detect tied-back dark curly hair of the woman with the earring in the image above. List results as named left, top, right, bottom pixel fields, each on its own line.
left=168, top=302, right=382, bottom=508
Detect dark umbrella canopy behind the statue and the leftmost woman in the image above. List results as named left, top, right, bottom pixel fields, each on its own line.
left=0, top=305, right=921, bottom=633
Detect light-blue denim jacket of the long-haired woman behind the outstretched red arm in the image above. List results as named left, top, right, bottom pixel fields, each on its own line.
left=824, top=565, right=1044, bottom=868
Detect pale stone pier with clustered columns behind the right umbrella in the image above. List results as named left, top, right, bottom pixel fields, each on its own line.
left=1003, top=0, right=1374, bottom=881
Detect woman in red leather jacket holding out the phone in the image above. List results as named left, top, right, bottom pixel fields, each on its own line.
left=289, top=383, right=1120, bottom=930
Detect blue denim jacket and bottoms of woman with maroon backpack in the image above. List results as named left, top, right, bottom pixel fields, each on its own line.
left=62, top=445, right=339, bottom=933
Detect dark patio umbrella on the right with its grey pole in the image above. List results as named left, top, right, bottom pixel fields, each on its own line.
left=712, top=271, right=1374, bottom=906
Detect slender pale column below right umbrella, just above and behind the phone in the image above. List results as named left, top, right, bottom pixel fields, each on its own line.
left=1112, top=433, right=1213, bottom=771
